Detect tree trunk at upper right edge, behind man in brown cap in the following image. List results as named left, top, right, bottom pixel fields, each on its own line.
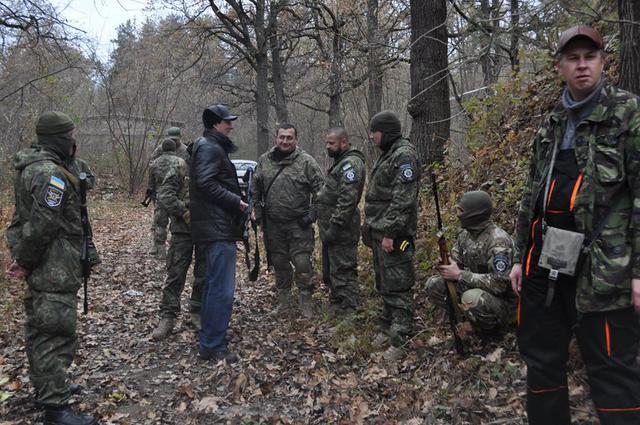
left=618, top=0, right=640, bottom=95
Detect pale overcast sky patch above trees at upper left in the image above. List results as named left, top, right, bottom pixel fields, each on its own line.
left=54, top=0, right=156, bottom=58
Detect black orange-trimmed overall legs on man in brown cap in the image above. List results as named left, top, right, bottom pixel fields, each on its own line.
left=517, top=267, right=640, bottom=425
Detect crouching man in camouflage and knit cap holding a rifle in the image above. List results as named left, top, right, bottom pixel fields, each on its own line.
left=427, top=190, right=514, bottom=336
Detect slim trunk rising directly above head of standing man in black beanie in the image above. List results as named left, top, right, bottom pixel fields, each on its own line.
left=367, top=0, right=382, bottom=119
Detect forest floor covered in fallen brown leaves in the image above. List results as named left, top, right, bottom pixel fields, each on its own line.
left=0, top=196, right=598, bottom=425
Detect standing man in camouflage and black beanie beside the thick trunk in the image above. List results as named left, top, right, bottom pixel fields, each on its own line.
left=362, top=111, right=420, bottom=361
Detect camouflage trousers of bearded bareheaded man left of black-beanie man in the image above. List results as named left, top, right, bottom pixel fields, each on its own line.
left=322, top=241, right=359, bottom=308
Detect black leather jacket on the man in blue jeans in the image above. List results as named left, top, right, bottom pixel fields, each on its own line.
left=189, top=129, right=244, bottom=243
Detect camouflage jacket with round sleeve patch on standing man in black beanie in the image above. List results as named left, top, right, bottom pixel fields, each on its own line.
left=364, top=139, right=420, bottom=239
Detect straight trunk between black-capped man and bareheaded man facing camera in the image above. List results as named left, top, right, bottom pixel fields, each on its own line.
left=255, top=0, right=269, bottom=156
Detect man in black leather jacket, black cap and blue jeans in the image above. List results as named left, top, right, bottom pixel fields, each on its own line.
left=189, top=105, right=247, bottom=362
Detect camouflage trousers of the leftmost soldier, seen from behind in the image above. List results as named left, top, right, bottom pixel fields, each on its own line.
left=24, top=289, right=77, bottom=406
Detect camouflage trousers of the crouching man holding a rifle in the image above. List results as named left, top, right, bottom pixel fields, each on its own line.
left=426, top=275, right=509, bottom=331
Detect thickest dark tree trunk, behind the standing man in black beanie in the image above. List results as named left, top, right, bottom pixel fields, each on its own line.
left=407, top=0, right=451, bottom=165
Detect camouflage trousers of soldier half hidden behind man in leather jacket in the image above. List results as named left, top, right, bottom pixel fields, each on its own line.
left=160, top=234, right=207, bottom=318
